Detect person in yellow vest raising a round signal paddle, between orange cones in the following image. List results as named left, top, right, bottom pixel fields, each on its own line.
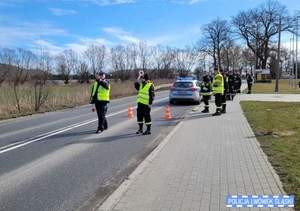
left=134, top=74, right=155, bottom=135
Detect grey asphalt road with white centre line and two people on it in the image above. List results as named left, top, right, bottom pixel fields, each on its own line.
left=0, top=91, right=195, bottom=211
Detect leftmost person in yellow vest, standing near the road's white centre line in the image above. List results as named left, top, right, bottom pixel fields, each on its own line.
left=90, top=70, right=110, bottom=133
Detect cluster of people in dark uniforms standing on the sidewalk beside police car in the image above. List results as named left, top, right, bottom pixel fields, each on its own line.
left=201, top=67, right=253, bottom=116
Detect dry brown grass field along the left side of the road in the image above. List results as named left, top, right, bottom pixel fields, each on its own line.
left=0, top=79, right=174, bottom=120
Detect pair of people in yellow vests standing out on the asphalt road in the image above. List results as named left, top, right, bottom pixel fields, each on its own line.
left=90, top=71, right=155, bottom=135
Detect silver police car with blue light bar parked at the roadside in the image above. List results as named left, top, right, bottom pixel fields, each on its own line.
left=169, top=77, right=201, bottom=105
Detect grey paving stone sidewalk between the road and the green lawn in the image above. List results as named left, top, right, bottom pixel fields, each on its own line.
left=99, top=84, right=300, bottom=211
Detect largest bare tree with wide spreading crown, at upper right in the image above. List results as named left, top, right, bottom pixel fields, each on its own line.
left=232, top=0, right=294, bottom=69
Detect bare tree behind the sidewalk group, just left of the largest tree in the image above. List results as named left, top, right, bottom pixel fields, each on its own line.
left=196, top=18, right=231, bottom=67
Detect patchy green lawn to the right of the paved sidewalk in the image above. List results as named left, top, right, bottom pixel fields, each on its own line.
left=241, top=80, right=300, bottom=211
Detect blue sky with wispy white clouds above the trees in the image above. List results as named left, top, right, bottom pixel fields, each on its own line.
left=0, top=0, right=300, bottom=53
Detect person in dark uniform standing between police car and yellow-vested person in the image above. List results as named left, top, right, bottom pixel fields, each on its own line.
left=201, top=70, right=212, bottom=113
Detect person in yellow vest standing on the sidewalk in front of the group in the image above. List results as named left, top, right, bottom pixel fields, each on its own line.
left=212, top=68, right=224, bottom=116
